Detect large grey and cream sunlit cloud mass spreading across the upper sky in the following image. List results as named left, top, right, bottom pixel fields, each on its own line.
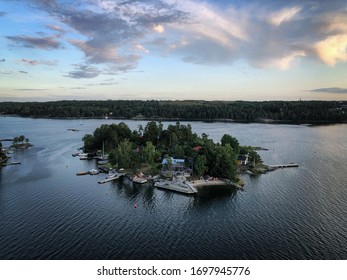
left=14, top=0, right=347, bottom=73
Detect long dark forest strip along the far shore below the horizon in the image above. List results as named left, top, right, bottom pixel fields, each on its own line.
left=0, top=100, right=347, bottom=123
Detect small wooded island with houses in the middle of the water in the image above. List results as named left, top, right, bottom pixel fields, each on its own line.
left=81, top=121, right=262, bottom=190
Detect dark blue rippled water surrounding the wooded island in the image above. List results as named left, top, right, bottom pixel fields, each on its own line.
left=0, top=117, right=347, bottom=259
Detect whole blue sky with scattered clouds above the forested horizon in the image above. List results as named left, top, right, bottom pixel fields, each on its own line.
left=0, top=0, right=347, bottom=101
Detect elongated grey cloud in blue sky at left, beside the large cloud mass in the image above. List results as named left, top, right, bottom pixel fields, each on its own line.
left=6, top=35, right=63, bottom=50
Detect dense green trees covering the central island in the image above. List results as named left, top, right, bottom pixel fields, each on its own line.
left=83, top=121, right=261, bottom=180
